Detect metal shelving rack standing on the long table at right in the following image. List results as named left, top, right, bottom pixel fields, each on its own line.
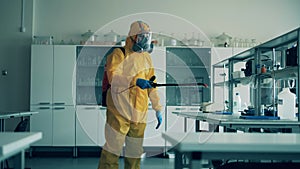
left=213, top=27, right=300, bottom=121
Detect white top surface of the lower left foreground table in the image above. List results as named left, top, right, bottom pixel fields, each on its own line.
left=0, top=132, right=42, bottom=161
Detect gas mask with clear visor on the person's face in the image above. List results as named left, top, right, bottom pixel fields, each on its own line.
left=130, top=32, right=153, bottom=53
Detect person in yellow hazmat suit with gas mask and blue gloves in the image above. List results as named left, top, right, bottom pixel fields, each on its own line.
left=98, top=21, right=162, bottom=169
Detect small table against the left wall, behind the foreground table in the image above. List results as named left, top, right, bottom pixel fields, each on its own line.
left=0, top=111, right=38, bottom=132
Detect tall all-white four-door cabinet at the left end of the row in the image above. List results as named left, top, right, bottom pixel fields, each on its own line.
left=30, top=45, right=76, bottom=146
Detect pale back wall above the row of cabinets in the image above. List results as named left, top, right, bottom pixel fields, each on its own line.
left=34, top=0, right=300, bottom=42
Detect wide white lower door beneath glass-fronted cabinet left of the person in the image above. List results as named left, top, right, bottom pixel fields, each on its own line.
left=76, top=106, right=100, bottom=146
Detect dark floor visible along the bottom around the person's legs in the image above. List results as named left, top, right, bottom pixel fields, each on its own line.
left=25, top=157, right=174, bottom=169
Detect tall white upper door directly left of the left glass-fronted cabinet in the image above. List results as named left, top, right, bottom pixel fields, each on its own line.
left=53, top=45, right=76, bottom=105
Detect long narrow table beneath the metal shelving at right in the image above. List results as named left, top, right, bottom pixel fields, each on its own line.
left=172, top=112, right=300, bottom=133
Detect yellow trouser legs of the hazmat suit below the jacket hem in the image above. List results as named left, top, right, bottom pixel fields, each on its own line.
left=98, top=109, right=146, bottom=169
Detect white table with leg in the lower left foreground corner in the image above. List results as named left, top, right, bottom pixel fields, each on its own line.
left=0, top=132, right=42, bottom=169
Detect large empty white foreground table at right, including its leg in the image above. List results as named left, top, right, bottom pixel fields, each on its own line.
left=162, top=132, right=300, bottom=169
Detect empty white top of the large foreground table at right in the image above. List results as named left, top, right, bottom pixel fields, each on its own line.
left=163, top=132, right=300, bottom=153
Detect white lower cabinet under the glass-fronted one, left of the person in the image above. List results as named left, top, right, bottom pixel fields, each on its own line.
left=76, top=106, right=106, bottom=146
